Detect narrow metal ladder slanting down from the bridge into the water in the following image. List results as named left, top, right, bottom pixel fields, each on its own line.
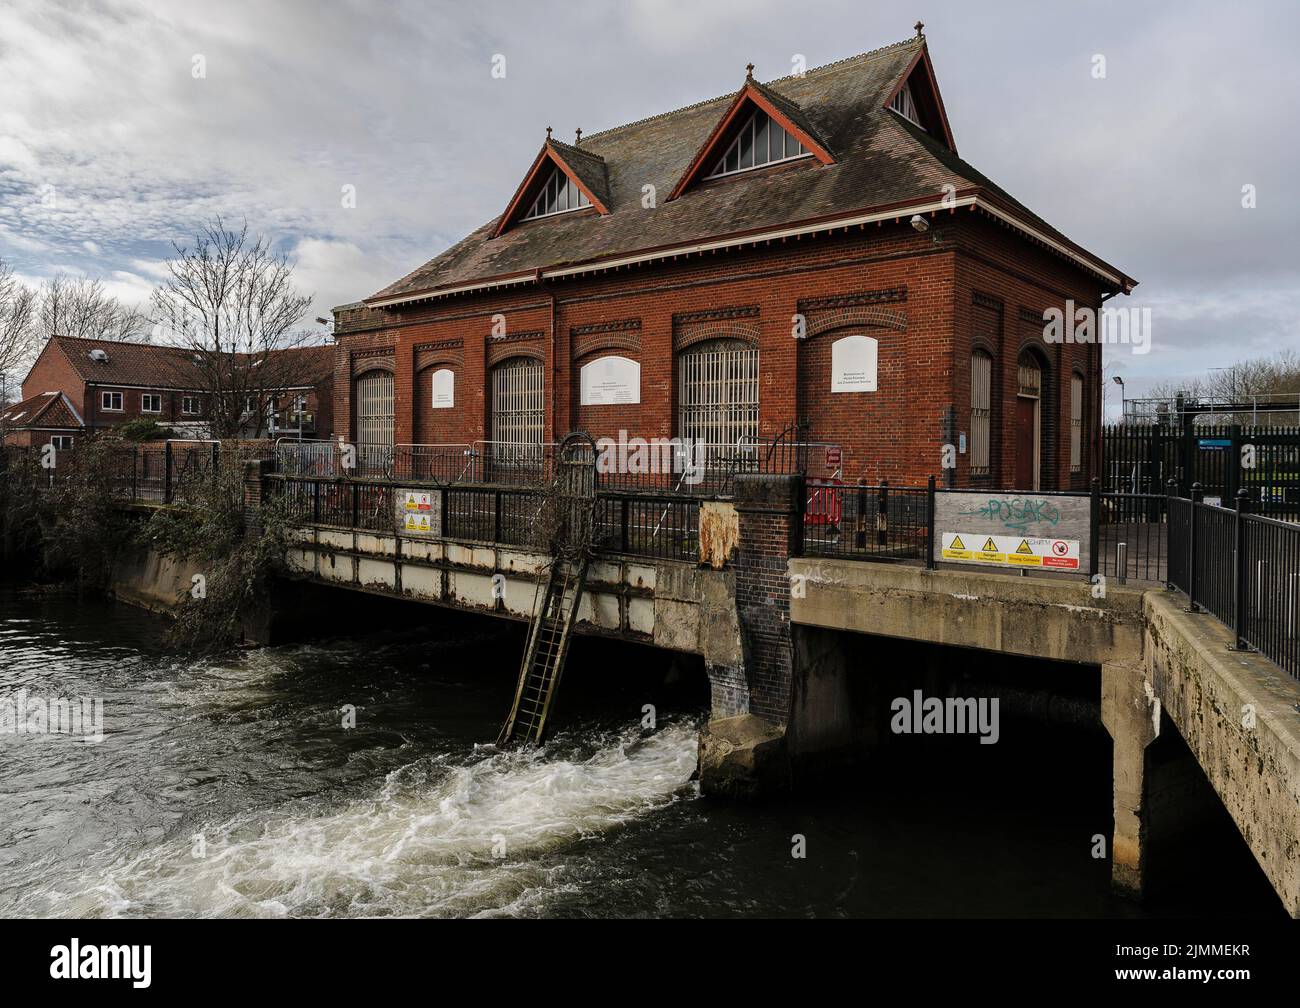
left=497, top=554, right=588, bottom=745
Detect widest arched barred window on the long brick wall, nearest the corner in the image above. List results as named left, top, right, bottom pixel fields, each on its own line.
left=677, top=339, right=758, bottom=458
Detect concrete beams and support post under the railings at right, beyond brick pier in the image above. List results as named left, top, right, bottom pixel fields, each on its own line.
left=780, top=559, right=1300, bottom=917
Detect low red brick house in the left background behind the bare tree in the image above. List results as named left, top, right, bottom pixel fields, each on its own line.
left=4, top=337, right=334, bottom=446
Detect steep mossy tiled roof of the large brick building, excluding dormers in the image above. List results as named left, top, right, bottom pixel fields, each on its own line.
left=367, top=38, right=1133, bottom=302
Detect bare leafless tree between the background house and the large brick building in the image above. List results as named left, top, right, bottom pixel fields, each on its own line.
left=152, top=216, right=312, bottom=438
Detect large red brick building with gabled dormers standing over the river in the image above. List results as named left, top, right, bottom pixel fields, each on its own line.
left=334, top=29, right=1135, bottom=489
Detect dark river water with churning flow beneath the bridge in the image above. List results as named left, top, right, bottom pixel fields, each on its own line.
left=0, top=589, right=1277, bottom=917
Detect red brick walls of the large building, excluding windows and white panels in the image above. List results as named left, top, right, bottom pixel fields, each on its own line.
left=334, top=215, right=1100, bottom=486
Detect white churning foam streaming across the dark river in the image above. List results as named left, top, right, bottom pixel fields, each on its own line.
left=34, top=722, right=698, bottom=917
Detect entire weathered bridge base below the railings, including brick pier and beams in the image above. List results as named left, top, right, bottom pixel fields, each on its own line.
left=246, top=470, right=1300, bottom=917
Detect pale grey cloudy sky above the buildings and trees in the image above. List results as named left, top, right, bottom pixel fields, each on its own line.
left=0, top=0, right=1300, bottom=411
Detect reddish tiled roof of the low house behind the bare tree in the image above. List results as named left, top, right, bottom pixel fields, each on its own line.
left=30, top=336, right=334, bottom=391
